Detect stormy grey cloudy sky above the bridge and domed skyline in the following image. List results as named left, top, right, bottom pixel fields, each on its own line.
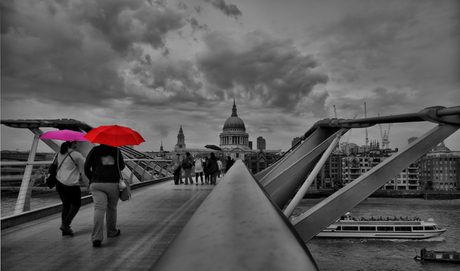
left=1, top=0, right=460, bottom=151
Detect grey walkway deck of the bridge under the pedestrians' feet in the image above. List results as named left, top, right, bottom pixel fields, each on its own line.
left=1, top=181, right=214, bottom=271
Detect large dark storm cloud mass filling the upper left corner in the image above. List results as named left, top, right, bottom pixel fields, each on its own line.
left=1, top=0, right=186, bottom=108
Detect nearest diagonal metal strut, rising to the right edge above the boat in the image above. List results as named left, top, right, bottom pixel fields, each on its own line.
left=292, top=124, right=460, bottom=242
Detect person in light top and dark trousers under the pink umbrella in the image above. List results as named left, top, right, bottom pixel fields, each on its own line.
left=56, top=141, right=89, bottom=236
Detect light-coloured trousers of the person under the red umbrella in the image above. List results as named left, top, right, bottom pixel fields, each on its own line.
left=90, top=183, right=120, bottom=241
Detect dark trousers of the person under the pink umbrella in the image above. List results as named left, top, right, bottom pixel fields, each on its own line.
left=56, top=181, right=81, bottom=227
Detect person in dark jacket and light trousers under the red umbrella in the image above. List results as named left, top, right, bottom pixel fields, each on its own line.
left=85, top=144, right=125, bottom=247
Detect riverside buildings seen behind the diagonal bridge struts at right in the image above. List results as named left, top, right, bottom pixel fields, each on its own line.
left=311, top=138, right=460, bottom=191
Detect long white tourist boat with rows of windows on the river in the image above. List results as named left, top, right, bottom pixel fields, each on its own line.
left=316, top=213, right=446, bottom=239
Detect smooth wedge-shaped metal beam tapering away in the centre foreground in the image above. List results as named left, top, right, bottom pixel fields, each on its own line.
left=150, top=161, right=318, bottom=271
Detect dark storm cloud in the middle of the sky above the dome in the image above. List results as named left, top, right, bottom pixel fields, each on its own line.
left=197, top=32, right=328, bottom=111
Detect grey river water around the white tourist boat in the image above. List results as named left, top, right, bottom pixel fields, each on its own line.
left=293, top=198, right=460, bottom=271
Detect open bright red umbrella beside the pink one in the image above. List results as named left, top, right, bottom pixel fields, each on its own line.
left=85, top=125, right=145, bottom=147
